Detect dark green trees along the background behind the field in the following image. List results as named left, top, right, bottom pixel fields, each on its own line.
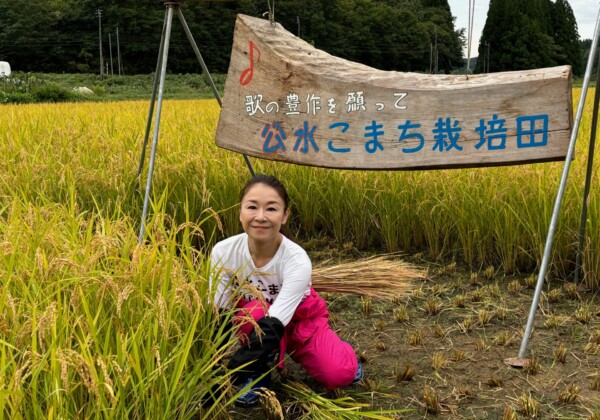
left=0, top=0, right=581, bottom=74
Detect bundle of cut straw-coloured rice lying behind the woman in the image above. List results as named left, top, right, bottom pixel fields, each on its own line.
left=313, top=254, right=427, bottom=298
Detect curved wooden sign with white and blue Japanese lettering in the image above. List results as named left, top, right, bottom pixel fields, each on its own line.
left=216, top=15, right=573, bottom=170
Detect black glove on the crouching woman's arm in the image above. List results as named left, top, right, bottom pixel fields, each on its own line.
left=227, top=316, right=283, bottom=385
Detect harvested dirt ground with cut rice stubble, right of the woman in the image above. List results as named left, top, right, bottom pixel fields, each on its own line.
left=226, top=254, right=600, bottom=419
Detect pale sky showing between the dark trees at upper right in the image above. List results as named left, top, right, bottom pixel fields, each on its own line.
left=448, top=0, right=600, bottom=57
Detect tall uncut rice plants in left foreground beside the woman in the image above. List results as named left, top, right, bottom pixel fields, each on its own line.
left=0, top=194, right=239, bottom=418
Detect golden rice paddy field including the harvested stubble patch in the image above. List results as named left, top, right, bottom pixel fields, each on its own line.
left=0, top=88, right=600, bottom=419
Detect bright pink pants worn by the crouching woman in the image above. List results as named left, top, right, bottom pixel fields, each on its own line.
left=233, top=289, right=358, bottom=391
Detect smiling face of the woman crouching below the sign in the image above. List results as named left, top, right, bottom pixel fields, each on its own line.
left=240, top=183, right=289, bottom=242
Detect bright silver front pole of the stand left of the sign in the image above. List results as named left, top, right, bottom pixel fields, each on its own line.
left=138, top=2, right=172, bottom=244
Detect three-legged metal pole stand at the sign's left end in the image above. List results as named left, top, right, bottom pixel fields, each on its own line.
left=137, top=0, right=255, bottom=244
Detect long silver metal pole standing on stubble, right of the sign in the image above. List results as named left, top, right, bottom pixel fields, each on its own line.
left=518, top=10, right=600, bottom=358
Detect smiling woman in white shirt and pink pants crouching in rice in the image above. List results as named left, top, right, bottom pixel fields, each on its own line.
left=211, top=175, right=362, bottom=407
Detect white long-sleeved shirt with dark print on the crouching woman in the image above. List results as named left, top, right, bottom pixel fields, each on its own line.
left=210, top=233, right=312, bottom=325
